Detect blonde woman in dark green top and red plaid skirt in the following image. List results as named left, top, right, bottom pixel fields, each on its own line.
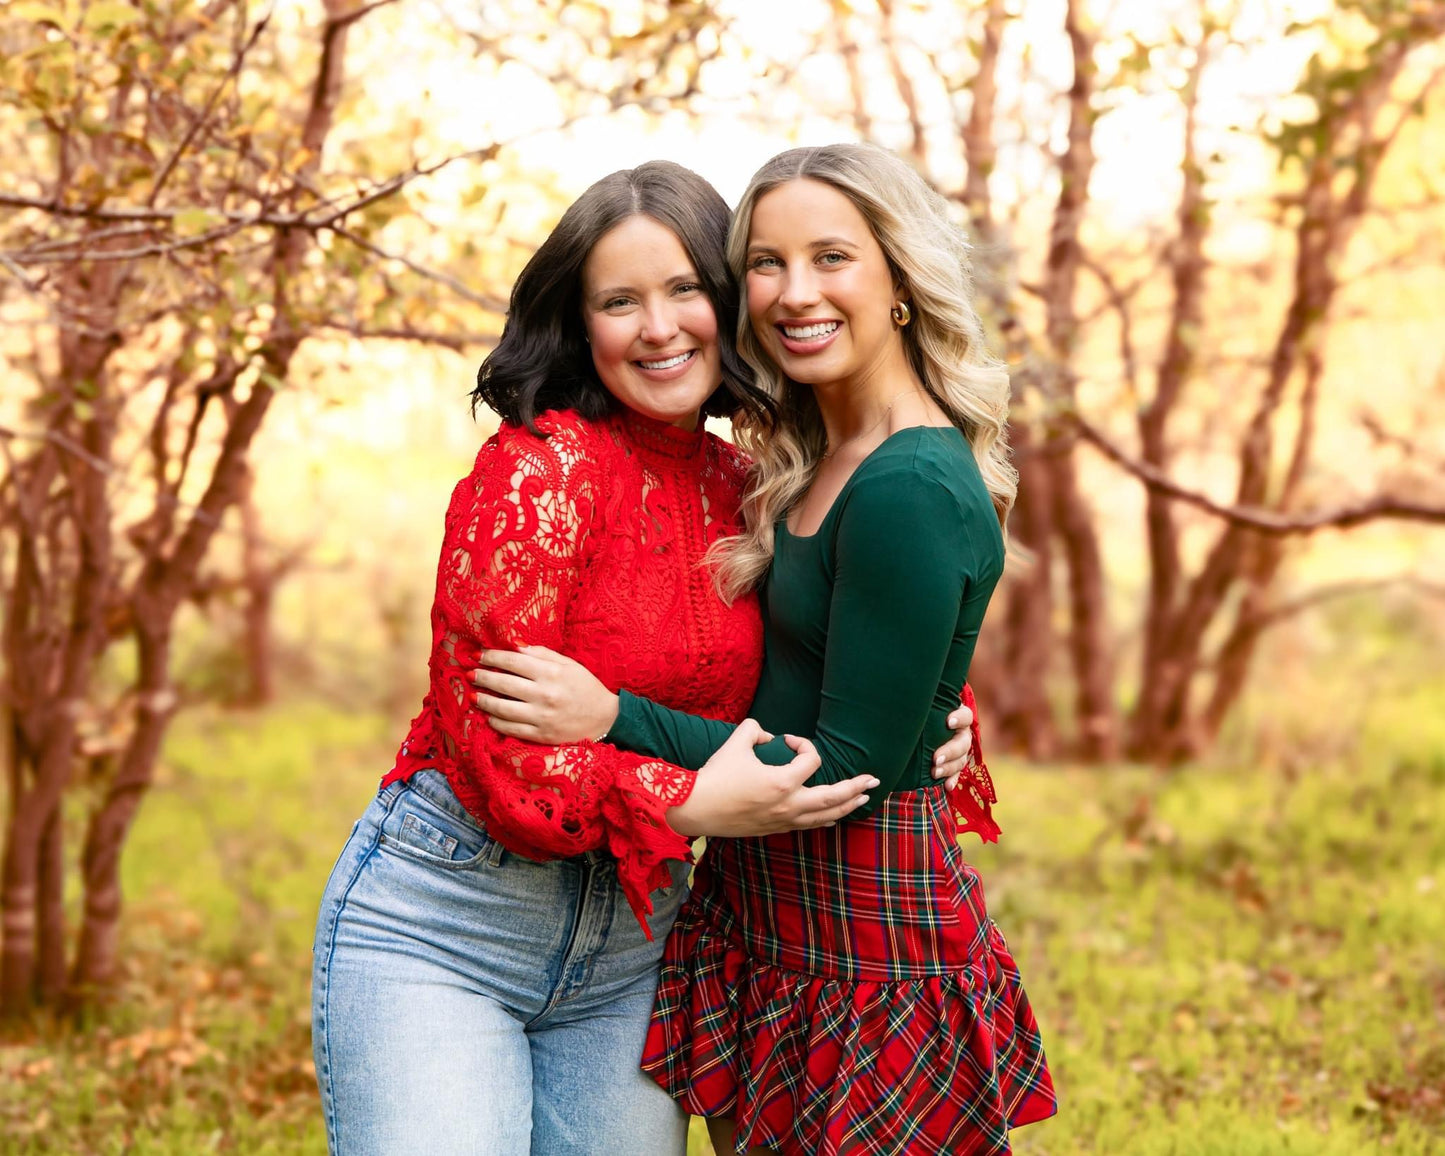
left=473, top=145, right=1055, bottom=1156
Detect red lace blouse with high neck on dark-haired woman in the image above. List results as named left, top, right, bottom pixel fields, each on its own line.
left=383, top=412, right=763, bottom=928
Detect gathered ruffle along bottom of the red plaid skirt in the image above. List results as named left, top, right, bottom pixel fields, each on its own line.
left=642, top=896, right=1056, bottom=1156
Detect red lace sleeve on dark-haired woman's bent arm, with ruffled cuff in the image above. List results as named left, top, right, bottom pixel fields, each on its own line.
left=431, top=419, right=696, bottom=929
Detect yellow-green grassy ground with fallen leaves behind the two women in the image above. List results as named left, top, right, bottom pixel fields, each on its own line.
left=0, top=686, right=1445, bottom=1156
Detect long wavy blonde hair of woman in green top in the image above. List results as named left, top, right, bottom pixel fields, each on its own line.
left=708, top=145, right=1019, bottom=600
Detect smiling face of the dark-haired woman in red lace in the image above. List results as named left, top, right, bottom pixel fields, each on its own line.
left=582, top=214, right=723, bottom=429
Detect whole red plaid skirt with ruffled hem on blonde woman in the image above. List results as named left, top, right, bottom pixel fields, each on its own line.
left=642, top=786, right=1056, bottom=1156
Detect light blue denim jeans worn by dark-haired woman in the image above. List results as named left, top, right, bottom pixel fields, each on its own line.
left=311, top=770, right=688, bottom=1156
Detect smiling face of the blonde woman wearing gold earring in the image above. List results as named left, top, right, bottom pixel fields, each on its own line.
left=747, top=178, right=902, bottom=384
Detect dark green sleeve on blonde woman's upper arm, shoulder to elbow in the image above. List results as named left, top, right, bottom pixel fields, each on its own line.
left=811, top=470, right=971, bottom=816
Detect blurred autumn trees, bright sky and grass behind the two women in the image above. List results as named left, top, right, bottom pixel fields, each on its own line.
left=0, top=0, right=1445, bottom=1156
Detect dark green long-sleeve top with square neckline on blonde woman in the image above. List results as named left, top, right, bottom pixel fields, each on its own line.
left=607, top=426, right=1004, bottom=816
